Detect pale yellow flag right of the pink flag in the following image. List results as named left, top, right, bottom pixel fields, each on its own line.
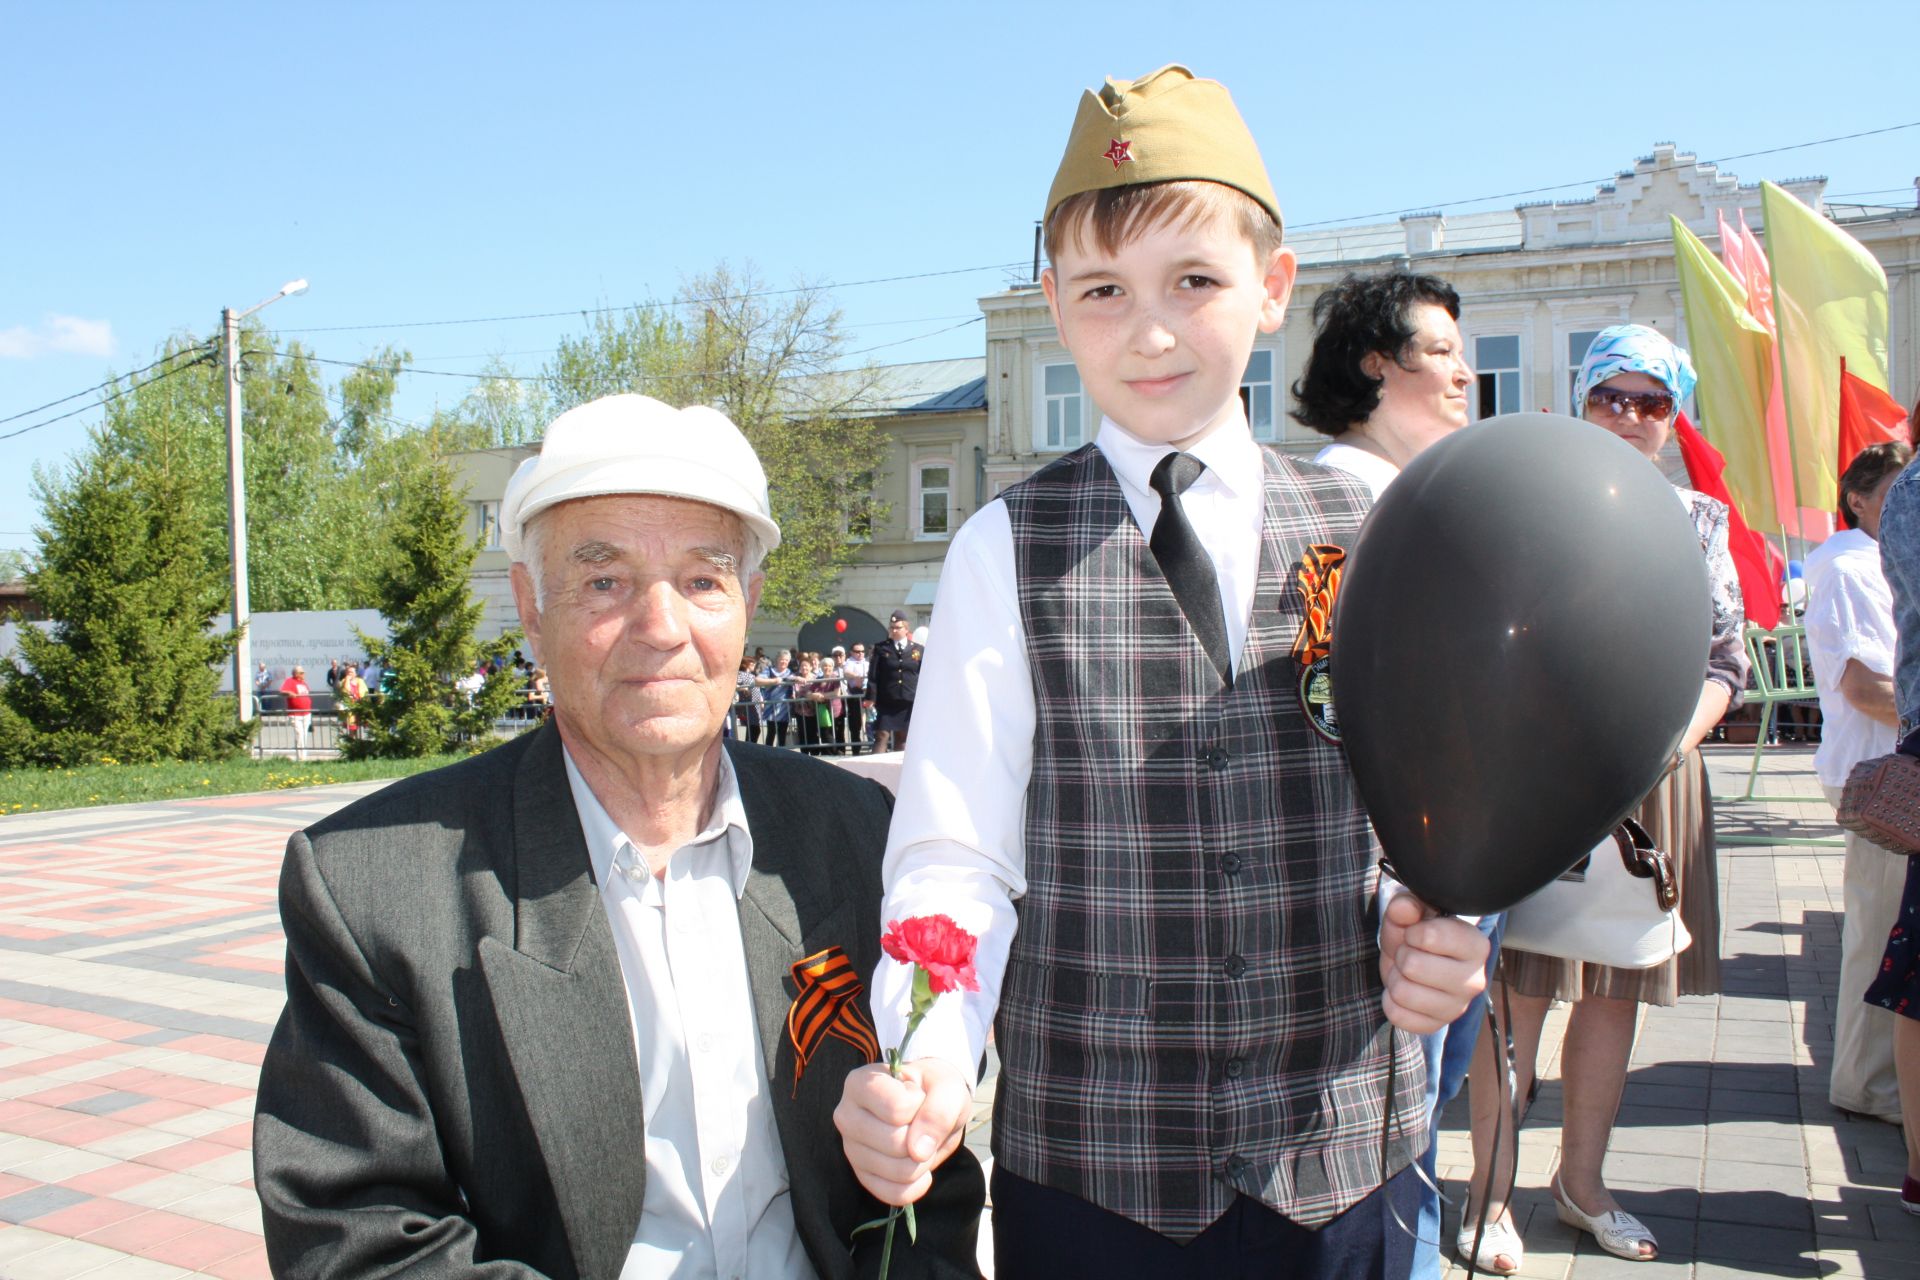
left=1761, top=182, right=1887, bottom=510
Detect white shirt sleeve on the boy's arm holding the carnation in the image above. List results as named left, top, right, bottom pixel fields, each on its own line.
left=874, top=501, right=1035, bottom=1082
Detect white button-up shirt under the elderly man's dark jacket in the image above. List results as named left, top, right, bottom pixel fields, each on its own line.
left=566, top=752, right=814, bottom=1280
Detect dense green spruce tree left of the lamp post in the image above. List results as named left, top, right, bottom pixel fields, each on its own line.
left=0, top=432, right=252, bottom=764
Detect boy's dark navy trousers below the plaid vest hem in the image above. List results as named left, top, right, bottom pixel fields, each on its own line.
left=993, top=1163, right=1421, bottom=1280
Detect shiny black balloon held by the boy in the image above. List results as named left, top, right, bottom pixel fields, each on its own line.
left=1331, top=415, right=1713, bottom=913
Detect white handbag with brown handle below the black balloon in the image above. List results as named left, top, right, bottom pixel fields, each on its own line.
left=1501, top=818, right=1693, bottom=969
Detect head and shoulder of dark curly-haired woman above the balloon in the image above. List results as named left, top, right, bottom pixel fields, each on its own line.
left=1292, top=271, right=1473, bottom=495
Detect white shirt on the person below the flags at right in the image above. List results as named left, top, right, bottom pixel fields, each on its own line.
left=1805, top=530, right=1897, bottom=787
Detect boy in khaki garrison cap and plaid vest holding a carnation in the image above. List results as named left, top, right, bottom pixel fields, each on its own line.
left=835, top=67, right=1486, bottom=1280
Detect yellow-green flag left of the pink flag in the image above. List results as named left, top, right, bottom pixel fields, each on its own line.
left=1672, top=219, right=1780, bottom=530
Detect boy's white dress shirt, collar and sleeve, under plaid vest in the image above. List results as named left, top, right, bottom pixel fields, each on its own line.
left=874, top=418, right=1265, bottom=1080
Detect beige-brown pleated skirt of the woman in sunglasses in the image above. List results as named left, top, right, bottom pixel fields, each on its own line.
left=1500, top=750, right=1720, bottom=1006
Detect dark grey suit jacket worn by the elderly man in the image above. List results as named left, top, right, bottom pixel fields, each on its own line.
left=253, top=725, right=985, bottom=1280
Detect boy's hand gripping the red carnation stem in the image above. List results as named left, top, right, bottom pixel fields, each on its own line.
left=833, top=1057, right=973, bottom=1205
